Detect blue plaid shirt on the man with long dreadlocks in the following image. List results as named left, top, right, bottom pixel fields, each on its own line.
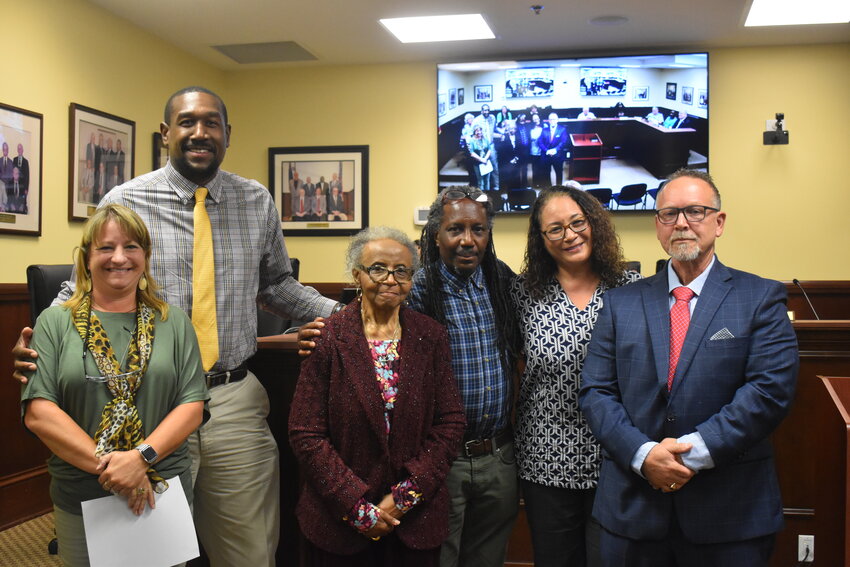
left=407, top=262, right=512, bottom=438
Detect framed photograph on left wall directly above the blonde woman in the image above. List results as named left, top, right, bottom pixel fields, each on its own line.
left=68, top=102, right=136, bottom=221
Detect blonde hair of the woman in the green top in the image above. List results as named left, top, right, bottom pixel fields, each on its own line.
left=62, top=203, right=168, bottom=321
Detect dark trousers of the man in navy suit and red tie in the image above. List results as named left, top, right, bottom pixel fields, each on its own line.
left=600, top=518, right=776, bottom=567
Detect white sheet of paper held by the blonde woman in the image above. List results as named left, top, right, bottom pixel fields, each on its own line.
left=83, top=477, right=200, bottom=567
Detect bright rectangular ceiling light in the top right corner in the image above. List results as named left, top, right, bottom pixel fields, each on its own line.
left=744, top=0, right=850, bottom=27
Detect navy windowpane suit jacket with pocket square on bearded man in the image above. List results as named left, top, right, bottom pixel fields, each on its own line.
left=579, top=260, right=798, bottom=543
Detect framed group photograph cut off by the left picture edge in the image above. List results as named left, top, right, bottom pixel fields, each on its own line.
left=0, top=103, right=44, bottom=236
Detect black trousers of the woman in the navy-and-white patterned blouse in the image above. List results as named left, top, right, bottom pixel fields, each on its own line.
left=520, top=480, right=601, bottom=567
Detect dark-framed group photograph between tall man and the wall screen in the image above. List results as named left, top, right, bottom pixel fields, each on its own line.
left=269, top=146, right=369, bottom=236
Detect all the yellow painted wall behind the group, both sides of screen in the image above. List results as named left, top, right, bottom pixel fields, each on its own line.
left=0, top=0, right=850, bottom=282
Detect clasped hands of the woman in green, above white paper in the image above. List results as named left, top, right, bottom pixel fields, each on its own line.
left=97, top=449, right=156, bottom=516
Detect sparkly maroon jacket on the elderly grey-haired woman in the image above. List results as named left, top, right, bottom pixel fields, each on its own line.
left=289, top=300, right=466, bottom=555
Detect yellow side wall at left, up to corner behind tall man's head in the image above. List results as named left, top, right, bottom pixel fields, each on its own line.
left=0, top=0, right=222, bottom=283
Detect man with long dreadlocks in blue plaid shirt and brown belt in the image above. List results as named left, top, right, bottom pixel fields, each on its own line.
left=408, top=187, right=519, bottom=567
